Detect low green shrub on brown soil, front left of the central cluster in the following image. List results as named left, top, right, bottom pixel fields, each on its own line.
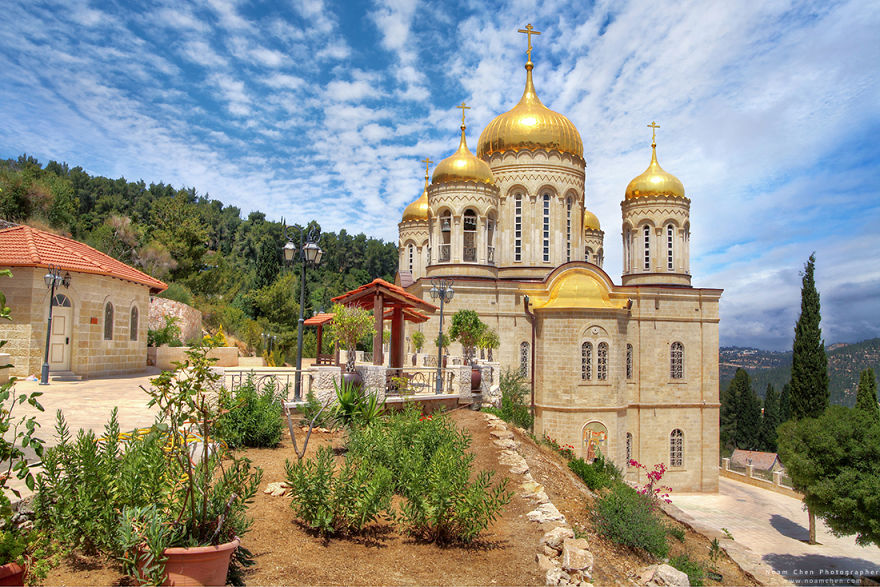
left=286, top=446, right=392, bottom=536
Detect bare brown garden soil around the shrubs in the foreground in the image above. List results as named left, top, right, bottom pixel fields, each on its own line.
left=46, top=409, right=756, bottom=585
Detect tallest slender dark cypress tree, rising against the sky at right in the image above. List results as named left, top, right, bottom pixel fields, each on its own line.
left=791, top=253, right=830, bottom=419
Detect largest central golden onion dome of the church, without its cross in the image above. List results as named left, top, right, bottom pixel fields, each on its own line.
left=477, top=60, right=584, bottom=159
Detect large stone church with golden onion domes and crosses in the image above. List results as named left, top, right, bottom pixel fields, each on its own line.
left=398, top=25, right=722, bottom=492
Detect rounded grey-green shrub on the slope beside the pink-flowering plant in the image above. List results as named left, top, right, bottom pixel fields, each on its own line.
left=592, top=482, right=669, bottom=557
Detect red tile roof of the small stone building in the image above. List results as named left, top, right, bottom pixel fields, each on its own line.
left=0, top=225, right=168, bottom=293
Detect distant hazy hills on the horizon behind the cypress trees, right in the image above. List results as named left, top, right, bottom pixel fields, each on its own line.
left=719, top=338, right=880, bottom=407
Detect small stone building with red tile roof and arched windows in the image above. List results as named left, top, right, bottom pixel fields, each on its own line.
left=0, top=225, right=167, bottom=377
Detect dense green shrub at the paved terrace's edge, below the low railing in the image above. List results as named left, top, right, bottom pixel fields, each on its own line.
left=217, top=375, right=287, bottom=448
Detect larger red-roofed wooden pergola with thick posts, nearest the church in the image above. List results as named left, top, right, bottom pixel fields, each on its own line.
left=330, top=279, right=438, bottom=369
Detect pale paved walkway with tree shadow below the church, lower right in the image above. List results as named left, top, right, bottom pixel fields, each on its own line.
left=672, top=478, right=880, bottom=585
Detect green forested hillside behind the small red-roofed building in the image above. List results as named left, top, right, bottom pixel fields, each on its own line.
left=0, top=155, right=397, bottom=356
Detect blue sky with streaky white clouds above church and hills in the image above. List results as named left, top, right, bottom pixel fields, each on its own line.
left=0, top=0, right=880, bottom=349
